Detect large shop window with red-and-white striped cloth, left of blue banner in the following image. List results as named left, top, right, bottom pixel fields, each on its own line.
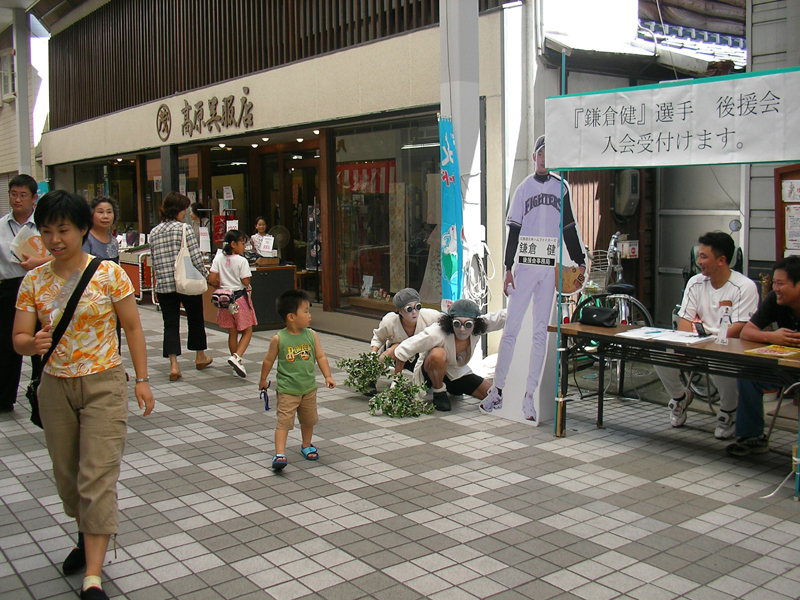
left=335, top=117, right=441, bottom=310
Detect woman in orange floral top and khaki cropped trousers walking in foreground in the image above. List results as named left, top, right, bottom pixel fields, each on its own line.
left=13, top=191, right=154, bottom=600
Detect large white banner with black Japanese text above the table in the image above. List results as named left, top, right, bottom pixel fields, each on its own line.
left=545, top=68, right=800, bottom=170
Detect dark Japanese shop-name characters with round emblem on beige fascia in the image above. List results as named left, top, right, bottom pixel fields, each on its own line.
left=156, top=87, right=253, bottom=142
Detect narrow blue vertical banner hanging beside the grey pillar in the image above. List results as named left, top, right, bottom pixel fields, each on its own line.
left=439, top=116, right=464, bottom=309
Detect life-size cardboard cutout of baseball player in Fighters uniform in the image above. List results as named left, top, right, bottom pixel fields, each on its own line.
left=480, top=136, right=586, bottom=424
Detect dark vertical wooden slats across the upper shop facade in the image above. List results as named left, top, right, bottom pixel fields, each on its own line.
left=49, top=0, right=502, bottom=129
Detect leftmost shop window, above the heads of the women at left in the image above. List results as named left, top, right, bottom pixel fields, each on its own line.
left=75, top=159, right=138, bottom=233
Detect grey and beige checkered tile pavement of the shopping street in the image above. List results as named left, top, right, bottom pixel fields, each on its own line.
left=0, top=307, right=800, bottom=600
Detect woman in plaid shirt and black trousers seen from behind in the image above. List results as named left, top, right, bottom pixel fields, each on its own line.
left=150, top=192, right=211, bottom=381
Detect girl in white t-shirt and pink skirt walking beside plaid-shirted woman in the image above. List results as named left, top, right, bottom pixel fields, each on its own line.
left=208, top=229, right=257, bottom=377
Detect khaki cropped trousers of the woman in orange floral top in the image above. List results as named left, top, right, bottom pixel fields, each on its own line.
left=39, top=365, right=128, bottom=535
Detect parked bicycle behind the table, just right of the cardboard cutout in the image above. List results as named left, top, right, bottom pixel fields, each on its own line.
left=570, top=231, right=653, bottom=395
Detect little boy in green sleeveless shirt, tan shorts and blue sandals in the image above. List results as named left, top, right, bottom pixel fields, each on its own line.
left=258, top=290, right=336, bottom=471
